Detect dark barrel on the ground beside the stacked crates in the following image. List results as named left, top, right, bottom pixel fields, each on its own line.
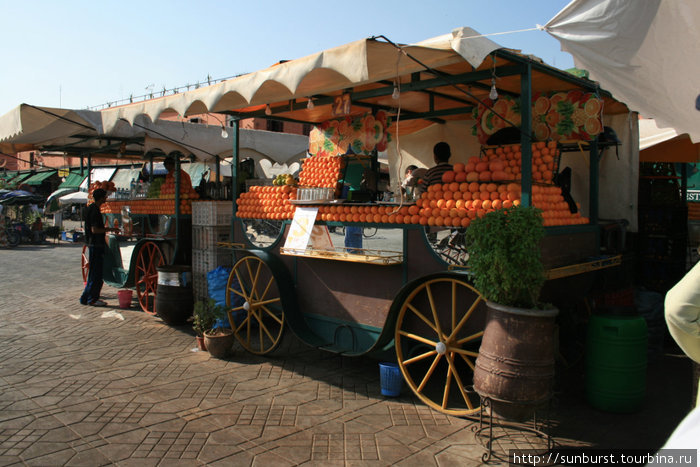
left=156, top=265, right=194, bottom=326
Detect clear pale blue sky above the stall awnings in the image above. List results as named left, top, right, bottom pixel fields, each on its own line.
left=0, top=0, right=574, bottom=115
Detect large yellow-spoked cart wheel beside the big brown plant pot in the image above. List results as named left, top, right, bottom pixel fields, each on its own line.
left=394, top=273, right=486, bottom=416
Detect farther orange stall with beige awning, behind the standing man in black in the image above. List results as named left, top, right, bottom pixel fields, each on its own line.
left=0, top=104, right=306, bottom=321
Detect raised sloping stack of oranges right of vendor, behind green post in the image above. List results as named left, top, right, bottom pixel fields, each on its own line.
left=442, top=141, right=559, bottom=183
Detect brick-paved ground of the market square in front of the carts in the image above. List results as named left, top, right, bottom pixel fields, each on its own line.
left=0, top=242, right=690, bottom=466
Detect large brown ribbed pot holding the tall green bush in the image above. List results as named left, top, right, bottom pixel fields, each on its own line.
left=474, top=302, right=558, bottom=421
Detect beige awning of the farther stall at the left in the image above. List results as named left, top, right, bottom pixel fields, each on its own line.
left=0, top=104, right=308, bottom=162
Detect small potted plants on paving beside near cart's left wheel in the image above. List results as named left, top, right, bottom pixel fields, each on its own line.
left=192, top=298, right=234, bottom=358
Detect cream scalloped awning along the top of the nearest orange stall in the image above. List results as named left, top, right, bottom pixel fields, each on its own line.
left=102, top=28, right=501, bottom=130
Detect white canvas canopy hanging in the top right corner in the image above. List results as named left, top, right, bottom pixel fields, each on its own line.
left=545, top=0, right=700, bottom=142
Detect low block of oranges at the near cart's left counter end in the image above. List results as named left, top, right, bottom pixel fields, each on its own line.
left=236, top=185, right=297, bottom=220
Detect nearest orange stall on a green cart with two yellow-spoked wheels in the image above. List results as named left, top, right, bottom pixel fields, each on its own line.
left=97, top=28, right=637, bottom=415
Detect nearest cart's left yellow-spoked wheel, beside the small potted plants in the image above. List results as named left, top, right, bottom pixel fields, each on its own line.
left=226, top=256, right=284, bottom=355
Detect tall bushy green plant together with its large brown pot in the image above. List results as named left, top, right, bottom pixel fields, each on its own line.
left=465, top=206, right=558, bottom=420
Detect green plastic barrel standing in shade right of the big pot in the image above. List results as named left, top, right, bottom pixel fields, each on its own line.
left=586, top=315, right=647, bottom=412
